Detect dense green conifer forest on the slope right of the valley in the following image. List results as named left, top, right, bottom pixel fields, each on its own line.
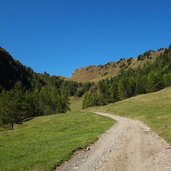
left=83, top=46, right=171, bottom=108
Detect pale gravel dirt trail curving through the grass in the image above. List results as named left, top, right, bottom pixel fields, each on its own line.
left=56, top=112, right=171, bottom=171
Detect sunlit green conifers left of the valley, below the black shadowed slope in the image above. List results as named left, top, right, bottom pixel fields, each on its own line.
left=0, top=77, right=91, bottom=128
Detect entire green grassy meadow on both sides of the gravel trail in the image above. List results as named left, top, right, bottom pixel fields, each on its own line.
left=0, top=87, right=171, bottom=171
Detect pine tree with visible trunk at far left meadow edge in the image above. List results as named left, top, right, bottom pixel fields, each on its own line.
left=0, top=82, right=27, bottom=129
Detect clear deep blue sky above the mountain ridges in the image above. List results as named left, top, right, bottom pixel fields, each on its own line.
left=0, top=0, right=171, bottom=77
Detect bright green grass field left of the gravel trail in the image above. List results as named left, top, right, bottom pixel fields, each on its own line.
left=0, top=112, right=113, bottom=171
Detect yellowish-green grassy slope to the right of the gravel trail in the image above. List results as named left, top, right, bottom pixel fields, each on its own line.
left=91, top=87, right=171, bottom=144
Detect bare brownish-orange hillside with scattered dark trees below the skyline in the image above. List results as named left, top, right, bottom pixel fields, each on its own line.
left=70, top=49, right=164, bottom=82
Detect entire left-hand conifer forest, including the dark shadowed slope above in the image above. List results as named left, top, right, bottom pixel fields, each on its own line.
left=0, top=48, right=92, bottom=128
